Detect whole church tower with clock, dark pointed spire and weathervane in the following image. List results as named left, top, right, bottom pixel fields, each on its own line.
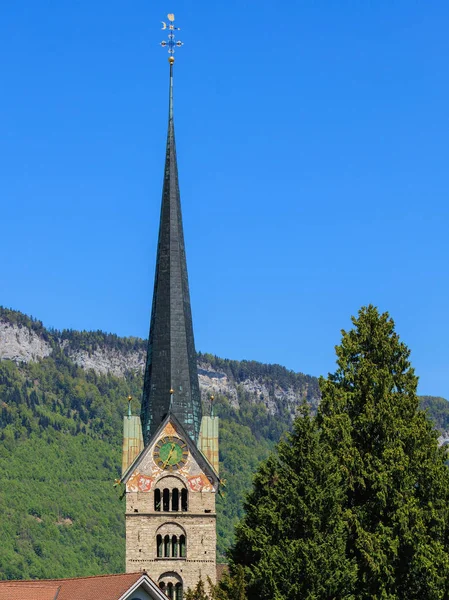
left=121, top=14, right=219, bottom=600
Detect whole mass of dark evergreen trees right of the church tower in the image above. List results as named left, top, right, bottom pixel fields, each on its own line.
left=231, top=306, right=449, bottom=600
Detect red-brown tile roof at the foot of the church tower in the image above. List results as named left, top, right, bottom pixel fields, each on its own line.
left=0, top=573, right=143, bottom=600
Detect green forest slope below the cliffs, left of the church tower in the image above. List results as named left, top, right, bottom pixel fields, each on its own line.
left=0, top=353, right=141, bottom=579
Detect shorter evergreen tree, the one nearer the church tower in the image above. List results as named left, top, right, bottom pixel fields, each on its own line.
left=231, top=406, right=355, bottom=600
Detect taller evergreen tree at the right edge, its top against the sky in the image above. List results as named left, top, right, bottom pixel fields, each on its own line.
left=318, top=306, right=449, bottom=600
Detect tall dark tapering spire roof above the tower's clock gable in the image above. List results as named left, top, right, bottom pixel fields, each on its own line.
left=141, top=55, right=202, bottom=445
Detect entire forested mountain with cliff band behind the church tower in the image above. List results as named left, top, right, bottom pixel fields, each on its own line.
left=0, top=309, right=449, bottom=578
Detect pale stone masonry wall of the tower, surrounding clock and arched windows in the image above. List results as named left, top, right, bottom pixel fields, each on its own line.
left=124, top=419, right=218, bottom=590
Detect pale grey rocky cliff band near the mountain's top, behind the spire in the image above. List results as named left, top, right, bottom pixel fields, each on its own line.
left=0, top=318, right=318, bottom=417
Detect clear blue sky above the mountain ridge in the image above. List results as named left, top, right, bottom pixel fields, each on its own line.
left=0, top=0, right=449, bottom=398
